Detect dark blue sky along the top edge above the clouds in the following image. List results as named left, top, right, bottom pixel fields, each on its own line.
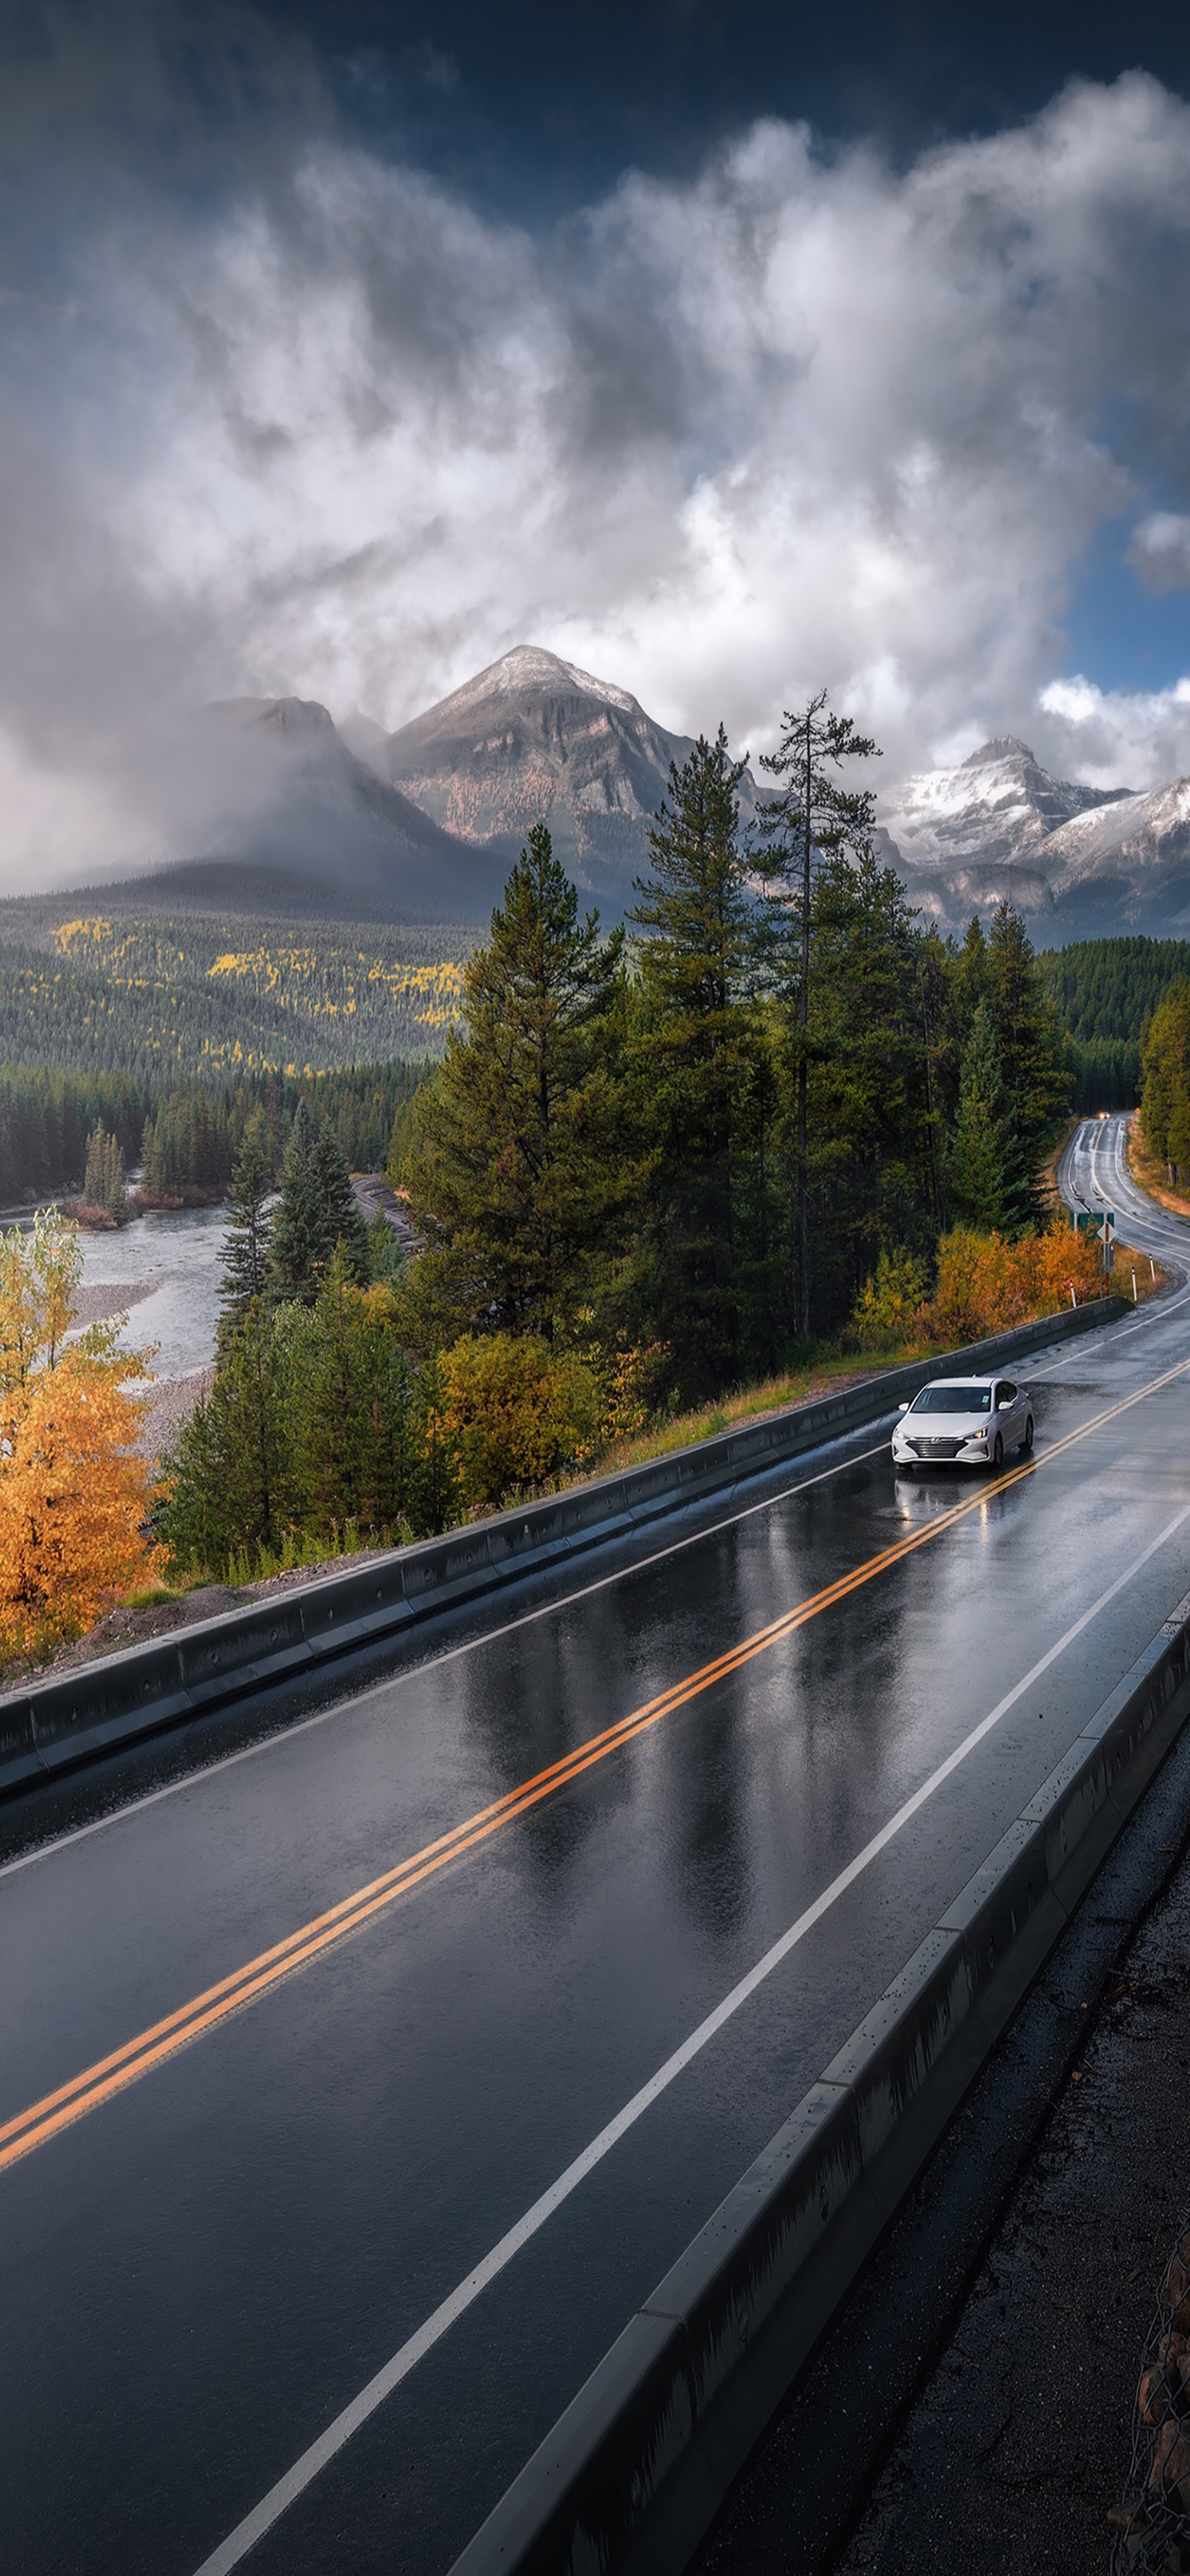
left=270, top=0, right=1190, bottom=211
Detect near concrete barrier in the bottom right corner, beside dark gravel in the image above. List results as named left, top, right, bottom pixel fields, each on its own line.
left=451, top=1594, right=1190, bottom=2576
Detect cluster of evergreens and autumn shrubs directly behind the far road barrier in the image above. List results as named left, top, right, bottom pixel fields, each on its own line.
left=160, top=752, right=1100, bottom=1579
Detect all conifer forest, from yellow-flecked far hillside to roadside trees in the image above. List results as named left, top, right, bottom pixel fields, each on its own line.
left=0, top=695, right=1190, bottom=1638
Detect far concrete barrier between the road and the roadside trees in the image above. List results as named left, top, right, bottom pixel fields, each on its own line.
left=0, top=1298, right=1125, bottom=1793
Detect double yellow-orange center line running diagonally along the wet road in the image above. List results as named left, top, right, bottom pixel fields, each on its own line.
left=0, top=1360, right=1190, bottom=2172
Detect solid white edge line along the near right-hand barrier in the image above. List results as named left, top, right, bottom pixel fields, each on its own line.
left=185, top=1502, right=1190, bottom=2576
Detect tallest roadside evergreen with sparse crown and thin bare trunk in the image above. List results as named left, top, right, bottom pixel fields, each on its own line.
left=758, top=688, right=879, bottom=1334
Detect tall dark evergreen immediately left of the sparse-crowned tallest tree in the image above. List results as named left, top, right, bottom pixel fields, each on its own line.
left=631, top=726, right=755, bottom=1393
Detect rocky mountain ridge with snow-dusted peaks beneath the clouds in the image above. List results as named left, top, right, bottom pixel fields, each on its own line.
left=100, top=644, right=1190, bottom=946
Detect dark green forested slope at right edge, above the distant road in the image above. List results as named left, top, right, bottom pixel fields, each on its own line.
left=1038, top=937, right=1190, bottom=1110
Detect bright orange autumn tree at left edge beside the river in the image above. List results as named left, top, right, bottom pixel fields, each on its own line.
left=0, top=1211, right=160, bottom=1656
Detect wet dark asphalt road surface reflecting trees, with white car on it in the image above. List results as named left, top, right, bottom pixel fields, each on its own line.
left=0, top=1121, right=1190, bottom=2576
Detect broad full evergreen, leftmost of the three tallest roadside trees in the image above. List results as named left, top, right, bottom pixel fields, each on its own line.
left=404, top=825, right=628, bottom=1339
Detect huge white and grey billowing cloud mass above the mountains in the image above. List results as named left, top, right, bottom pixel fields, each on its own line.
left=0, top=53, right=1190, bottom=881
